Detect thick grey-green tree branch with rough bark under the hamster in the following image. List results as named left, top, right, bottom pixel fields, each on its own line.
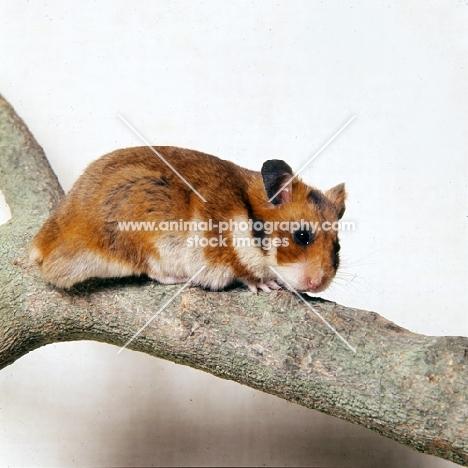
left=0, top=97, right=468, bottom=466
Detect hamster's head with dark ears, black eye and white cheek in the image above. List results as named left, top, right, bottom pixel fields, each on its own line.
left=261, top=160, right=346, bottom=293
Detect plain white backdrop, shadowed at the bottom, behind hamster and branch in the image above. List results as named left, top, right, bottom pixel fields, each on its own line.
left=0, top=0, right=468, bottom=467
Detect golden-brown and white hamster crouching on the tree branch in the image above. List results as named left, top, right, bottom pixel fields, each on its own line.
left=30, top=147, right=346, bottom=293
